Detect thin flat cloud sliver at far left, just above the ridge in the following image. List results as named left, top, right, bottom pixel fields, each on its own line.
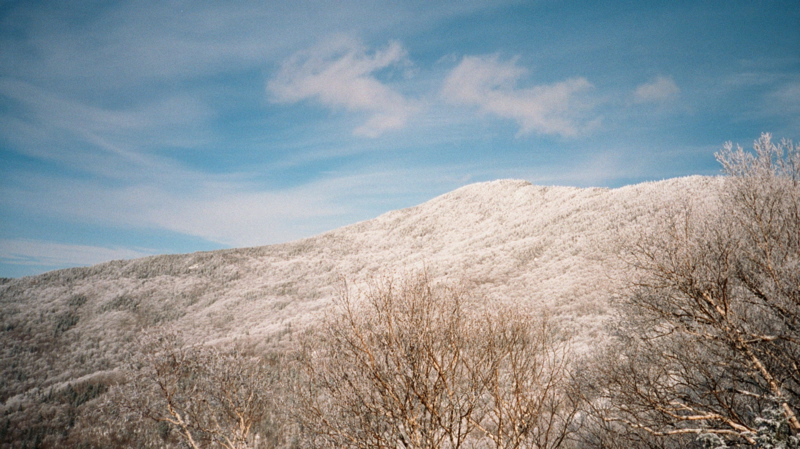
left=0, top=239, right=155, bottom=267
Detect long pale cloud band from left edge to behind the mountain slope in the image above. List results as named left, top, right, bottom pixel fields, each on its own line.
left=0, top=162, right=462, bottom=246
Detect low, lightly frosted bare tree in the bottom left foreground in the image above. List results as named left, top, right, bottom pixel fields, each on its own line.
left=88, top=334, right=290, bottom=449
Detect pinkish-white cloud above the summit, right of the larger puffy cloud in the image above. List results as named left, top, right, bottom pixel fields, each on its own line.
left=442, top=56, right=597, bottom=136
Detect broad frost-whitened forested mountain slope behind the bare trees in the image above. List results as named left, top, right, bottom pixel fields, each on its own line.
left=0, top=177, right=721, bottom=406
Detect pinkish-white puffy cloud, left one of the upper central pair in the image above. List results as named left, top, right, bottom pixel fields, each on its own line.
left=267, top=38, right=417, bottom=137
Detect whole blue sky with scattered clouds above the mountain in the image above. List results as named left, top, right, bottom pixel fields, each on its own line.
left=0, top=0, right=800, bottom=277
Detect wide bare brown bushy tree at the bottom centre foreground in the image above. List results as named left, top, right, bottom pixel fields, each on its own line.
left=290, top=275, right=576, bottom=449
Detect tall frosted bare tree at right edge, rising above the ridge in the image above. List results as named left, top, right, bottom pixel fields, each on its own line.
left=590, top=134, right=800, bottom=445
